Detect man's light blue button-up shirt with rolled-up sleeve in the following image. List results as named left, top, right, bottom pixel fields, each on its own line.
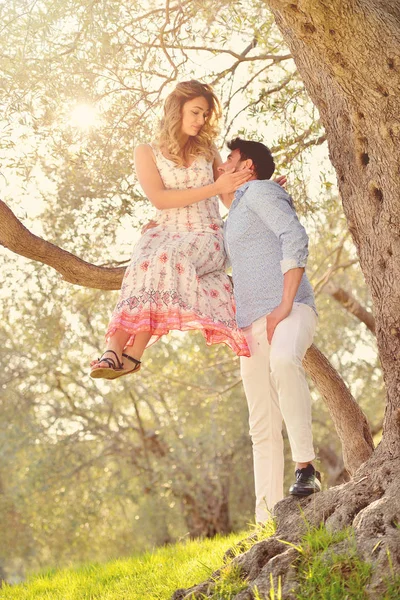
left=224, top=180, right=316, bottom=327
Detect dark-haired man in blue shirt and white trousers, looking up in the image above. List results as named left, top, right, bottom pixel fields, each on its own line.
left=219, top=138, right=321, bottom=523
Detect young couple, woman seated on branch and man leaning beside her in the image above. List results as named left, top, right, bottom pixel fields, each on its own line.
left=90, top=81, right=320, bottom=523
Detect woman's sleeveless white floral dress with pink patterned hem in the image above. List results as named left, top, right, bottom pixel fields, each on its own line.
left=106, top=145, right=250, bottom=356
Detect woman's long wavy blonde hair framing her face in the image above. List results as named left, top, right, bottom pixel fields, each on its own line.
left=157, top=79, right=221, bottom=166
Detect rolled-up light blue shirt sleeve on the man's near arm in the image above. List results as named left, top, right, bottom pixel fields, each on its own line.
left=247, top=182, right=308, bottom=274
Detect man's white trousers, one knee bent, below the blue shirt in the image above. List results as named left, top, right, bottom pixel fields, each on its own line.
left=240, top=302, right=318, bottom=523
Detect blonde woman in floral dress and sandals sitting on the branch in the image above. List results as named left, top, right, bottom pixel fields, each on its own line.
left=90, top=80, right=252, bottom=379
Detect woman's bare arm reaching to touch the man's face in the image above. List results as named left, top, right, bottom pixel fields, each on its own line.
left=135, top=144, right=251, bottom=210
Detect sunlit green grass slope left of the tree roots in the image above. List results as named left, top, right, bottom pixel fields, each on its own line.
left=0, top=529, right=273, bottom=600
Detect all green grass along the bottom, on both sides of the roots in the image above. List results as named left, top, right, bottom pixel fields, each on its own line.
left=0, top=524, right=400, bottom=600
